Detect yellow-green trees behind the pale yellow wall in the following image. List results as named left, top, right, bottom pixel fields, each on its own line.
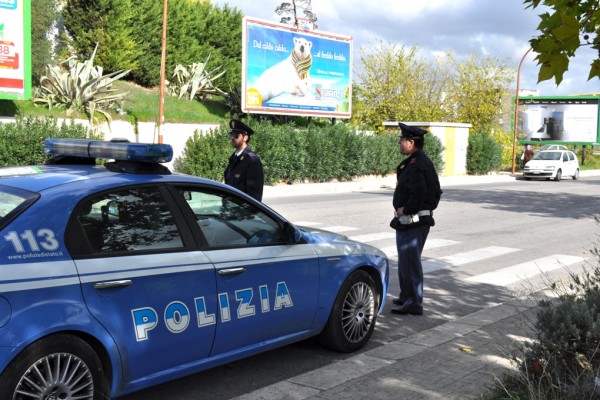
left=351, top=44, right=513, bottom=132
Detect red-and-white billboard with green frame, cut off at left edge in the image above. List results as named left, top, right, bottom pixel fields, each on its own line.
left=0, top=0, right=31, bottom=100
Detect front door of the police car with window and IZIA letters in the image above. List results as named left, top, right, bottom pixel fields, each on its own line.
left=171, top=187, right=319, bottom=355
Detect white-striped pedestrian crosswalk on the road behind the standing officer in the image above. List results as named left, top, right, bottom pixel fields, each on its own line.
left=297, top=221, right=585, bottom=286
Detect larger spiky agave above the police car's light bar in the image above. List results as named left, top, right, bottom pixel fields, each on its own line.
left=33, top=45, right=130, bottom=131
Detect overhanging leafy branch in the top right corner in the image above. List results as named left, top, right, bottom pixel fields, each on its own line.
left=524, top=0, right=600, bottom=85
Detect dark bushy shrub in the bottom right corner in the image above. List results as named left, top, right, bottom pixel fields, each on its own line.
left=486, top=225, right=600, bottom=400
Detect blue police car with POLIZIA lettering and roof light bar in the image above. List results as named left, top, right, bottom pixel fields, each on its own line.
left=0, top=139, right=389, bottom=399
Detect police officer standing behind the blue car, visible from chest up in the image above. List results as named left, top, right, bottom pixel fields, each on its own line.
left=225, top=119, right=265, bottom=201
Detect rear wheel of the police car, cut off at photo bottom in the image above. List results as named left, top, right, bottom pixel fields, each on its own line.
left=0, top=334, right=110, bottom=400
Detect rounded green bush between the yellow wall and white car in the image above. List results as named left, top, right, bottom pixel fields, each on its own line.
left=467, top=133, right=502, bottom=175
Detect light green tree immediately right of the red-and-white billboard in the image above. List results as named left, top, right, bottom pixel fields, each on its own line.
left=31, top=0, right=58, bottom=83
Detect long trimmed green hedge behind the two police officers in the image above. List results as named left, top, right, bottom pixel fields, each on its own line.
left=176, top=120, right=444, bottom=184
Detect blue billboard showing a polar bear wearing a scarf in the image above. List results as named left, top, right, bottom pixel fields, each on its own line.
left=242, top=17, right=352, bottom=118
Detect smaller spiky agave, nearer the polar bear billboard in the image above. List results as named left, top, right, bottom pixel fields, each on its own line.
left=167, top=55, right=227, bottom=101
